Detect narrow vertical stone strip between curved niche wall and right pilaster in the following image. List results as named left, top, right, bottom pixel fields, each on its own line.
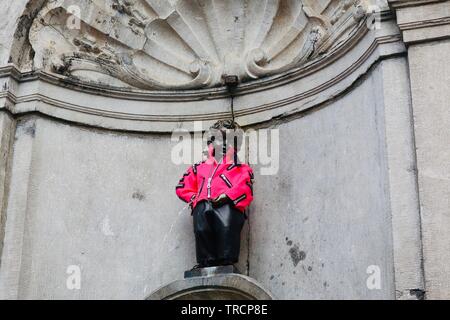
left=382, top=58, right=425, bottom=299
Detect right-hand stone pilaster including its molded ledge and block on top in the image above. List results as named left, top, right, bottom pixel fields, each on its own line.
left=390, top=0, right=450, bottom=299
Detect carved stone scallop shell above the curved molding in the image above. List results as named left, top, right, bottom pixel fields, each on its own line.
left=29, top=0, right=364, bottom=90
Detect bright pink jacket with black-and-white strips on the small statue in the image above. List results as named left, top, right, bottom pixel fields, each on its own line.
left=176, top=146, right=253, bottom=212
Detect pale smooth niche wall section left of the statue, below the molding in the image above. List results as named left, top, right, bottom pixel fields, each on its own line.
left=0, top=117, right=247, bottom=299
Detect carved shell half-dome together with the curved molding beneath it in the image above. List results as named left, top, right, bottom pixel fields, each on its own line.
left=2, top=0, right=384, bottom=132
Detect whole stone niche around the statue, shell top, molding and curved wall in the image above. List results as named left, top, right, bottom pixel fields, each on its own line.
left=0, top=0, right=420, bottom=299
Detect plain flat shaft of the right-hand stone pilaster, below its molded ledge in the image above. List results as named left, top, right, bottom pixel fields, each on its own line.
left=409, top=40, right=450, bottom=299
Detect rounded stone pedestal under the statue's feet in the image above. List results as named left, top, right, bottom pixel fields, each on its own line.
left=147, top=266, right=273, bottom=300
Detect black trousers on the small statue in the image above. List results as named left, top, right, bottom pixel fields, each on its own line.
left=192, top=201, right=245, bottom=267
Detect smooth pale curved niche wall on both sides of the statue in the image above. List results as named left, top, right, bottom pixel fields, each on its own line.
left=0, top=56, right=400, bottom=299
